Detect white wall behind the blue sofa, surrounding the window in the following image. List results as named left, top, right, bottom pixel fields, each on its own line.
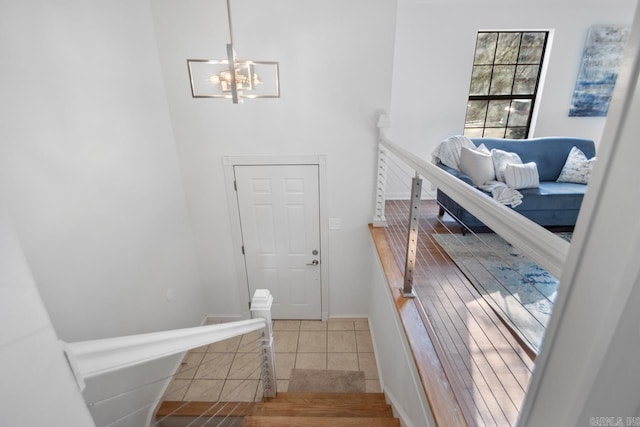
left=389, top=0, right=636, bottom=193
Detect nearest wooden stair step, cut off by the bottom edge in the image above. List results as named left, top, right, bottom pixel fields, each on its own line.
left=242, top=415, right=400, bottom=427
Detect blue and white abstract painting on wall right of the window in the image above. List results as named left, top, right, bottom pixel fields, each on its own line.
left=569, top=26, right=629, bottom=117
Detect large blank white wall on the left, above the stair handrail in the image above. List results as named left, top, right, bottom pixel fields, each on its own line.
left=0, top=0, right=204, bottom=341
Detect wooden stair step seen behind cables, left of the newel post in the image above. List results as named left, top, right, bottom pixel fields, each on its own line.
left=156, top=401, right=256, bottom=417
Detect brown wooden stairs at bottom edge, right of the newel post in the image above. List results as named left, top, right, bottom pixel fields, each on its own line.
left=243, top=393, right=400, bottom=427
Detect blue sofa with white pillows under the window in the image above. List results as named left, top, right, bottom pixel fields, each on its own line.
left=436, top=137, right=596, bottom=229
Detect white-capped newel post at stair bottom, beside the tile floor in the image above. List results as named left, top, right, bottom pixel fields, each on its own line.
left=251, top=289, right=277, bottom=397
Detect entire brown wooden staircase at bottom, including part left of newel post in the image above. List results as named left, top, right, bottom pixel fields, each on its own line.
left=156, top=393, right=400, bottom=427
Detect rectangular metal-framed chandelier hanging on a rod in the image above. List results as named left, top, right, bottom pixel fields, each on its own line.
left=187, top=0, right=280, bottom=104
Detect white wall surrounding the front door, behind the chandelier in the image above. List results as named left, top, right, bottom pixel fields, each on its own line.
left=152, top=0, right=396, bottom=316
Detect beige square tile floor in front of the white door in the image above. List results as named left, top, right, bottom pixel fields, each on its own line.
left=164, top=319, right=381, bottom=401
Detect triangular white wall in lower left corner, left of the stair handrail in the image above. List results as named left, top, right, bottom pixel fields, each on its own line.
left=0, top=206, right=92, bottom=427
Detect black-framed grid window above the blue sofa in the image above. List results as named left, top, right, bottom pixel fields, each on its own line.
left=464, top=31, right=549, bottom=139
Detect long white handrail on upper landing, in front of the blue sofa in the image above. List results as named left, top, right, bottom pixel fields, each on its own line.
left=379, top=135, right=570, bottom=277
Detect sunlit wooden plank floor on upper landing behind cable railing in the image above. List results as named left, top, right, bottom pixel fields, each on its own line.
left=385, top=201, right=534, bottom=426
